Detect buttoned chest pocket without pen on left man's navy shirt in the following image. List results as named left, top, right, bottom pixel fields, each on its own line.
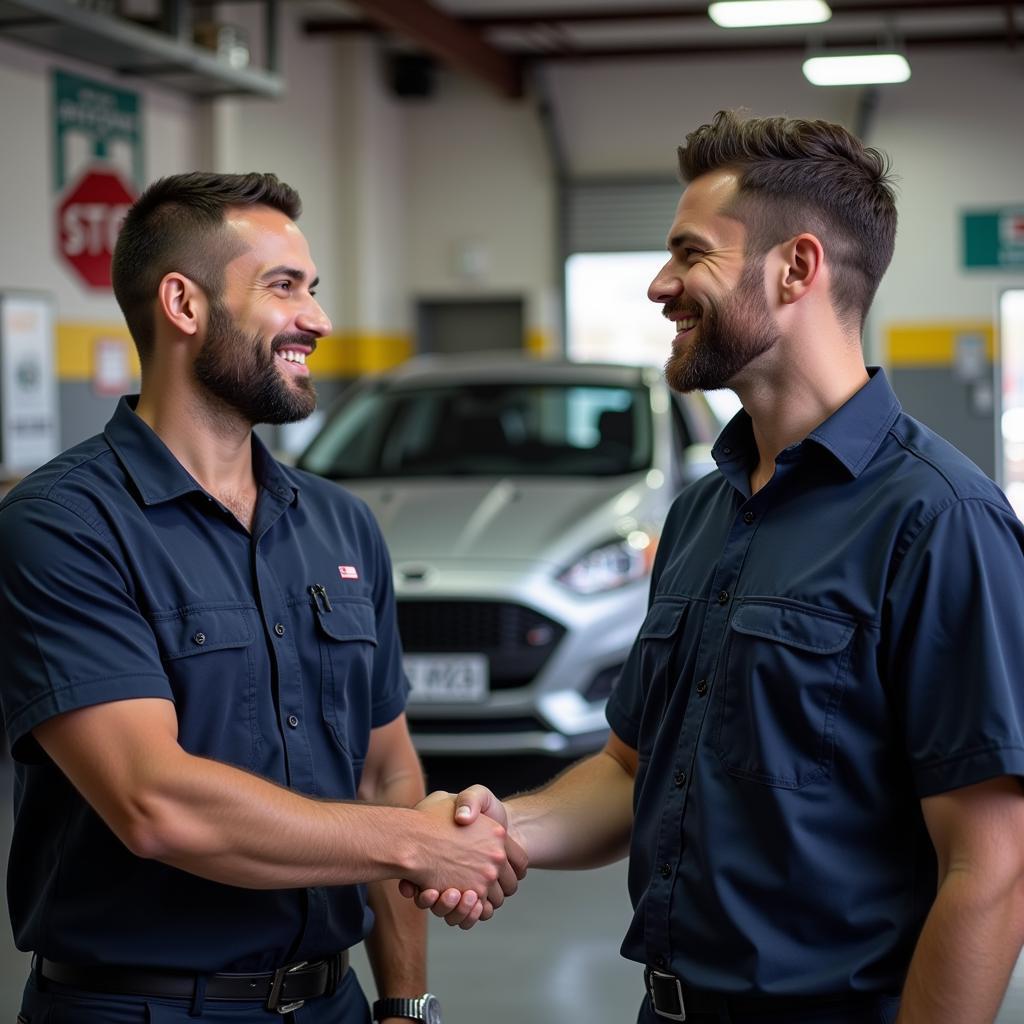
left=150, top=605, right=261, bottom=768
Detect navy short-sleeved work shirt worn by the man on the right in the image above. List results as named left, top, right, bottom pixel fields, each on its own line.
left=608, top=371, right=1024, bottom=995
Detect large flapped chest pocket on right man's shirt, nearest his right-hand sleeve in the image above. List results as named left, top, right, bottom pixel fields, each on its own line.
left=715, top=600, right=856, bottom=790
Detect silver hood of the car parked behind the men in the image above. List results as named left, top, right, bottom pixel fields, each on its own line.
left=344, top=473, right=647, bottom=562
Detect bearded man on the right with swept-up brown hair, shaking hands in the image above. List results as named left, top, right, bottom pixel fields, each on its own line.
left=415, top=112, right=1024, bottom=1024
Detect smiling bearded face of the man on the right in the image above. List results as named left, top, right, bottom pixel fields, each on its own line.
left=647, top=171, right=778, bottom=391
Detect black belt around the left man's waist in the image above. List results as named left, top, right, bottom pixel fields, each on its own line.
left=39, top=949, right=348, bottom=1014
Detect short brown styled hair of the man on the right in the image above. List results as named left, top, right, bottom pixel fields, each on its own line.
left=678, top=111, right=896, bottom=328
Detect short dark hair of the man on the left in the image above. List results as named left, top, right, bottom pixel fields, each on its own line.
left=111, top=171, right=302, bottom=364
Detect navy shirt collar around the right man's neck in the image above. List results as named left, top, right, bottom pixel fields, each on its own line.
left=712, top=367, right=901, bottom=478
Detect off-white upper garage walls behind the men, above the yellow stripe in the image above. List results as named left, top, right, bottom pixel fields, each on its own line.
left=6, top=22, right=1024, bottom=448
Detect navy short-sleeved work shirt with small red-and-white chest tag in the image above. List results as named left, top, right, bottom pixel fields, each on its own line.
left=0, top=399, right=408, bottom=972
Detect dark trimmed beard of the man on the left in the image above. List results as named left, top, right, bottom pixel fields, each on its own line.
left=194, top=302, right=316, bottom=426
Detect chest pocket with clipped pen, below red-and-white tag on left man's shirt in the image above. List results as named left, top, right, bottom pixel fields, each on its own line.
left=315, top=597, right=377, bottom=766
